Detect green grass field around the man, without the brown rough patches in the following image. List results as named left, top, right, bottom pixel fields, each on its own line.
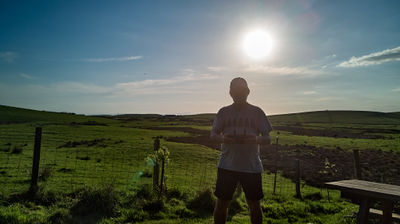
left=0, top=106, right=400, bottom=223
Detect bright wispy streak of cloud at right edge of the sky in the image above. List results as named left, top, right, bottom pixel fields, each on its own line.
left=338, top=47, right=400, bottom=67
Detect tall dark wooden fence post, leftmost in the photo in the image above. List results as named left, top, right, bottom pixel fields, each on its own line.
left=29, top=127, right=42, bottom=193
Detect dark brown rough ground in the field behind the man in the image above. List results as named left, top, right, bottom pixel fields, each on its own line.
left=143, top=127, right=400, bottom=186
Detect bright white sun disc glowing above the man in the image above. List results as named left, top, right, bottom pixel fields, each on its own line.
left=243, top=30, right=272, bottom=59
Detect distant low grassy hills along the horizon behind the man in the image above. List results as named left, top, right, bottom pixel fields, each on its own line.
left=0, top=105, right=400, bottom=126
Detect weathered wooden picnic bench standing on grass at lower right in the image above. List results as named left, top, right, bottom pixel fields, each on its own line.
left=325, top=180, right=400, bottom=224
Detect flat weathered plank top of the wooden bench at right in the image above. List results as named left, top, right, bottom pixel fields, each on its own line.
left=325, top=180, right=400, bottom=201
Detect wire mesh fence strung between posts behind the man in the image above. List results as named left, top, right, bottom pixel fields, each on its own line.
left=0, top=126, right=396, bottom=207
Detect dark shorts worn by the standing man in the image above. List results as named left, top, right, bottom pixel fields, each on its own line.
left=214, top=168, right=264, bottom=201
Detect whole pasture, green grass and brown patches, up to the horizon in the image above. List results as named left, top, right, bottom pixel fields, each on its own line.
left=0, top=106, right=400, bottom=223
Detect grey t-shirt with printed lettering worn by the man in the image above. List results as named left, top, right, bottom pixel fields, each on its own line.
left=211, top=104, right=272, bottom=173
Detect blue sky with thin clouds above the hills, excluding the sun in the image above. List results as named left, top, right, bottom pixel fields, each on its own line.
left=0, top=0, right=400, bottom=114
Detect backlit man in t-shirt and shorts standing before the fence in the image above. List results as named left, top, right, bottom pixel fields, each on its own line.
left=211, top=77, right=272, bottom=224
